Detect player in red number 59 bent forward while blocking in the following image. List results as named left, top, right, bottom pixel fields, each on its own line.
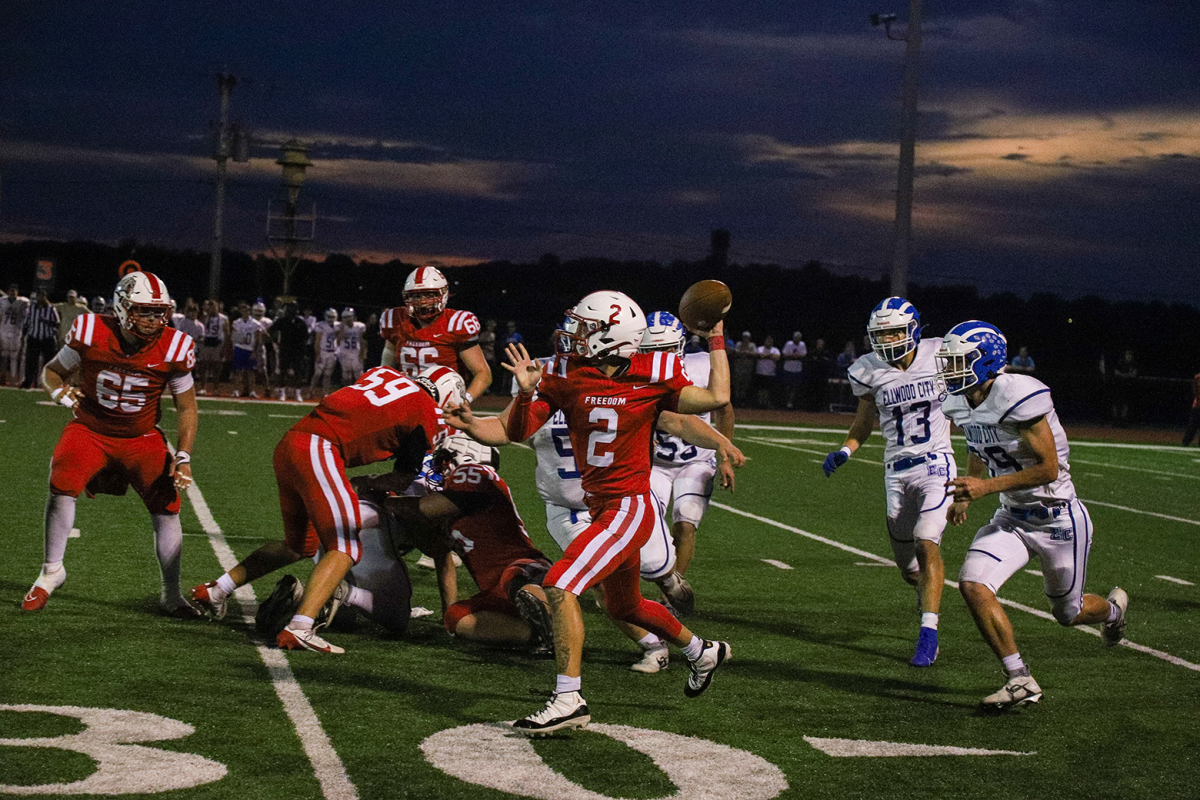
left=192, top=367, right=463, bottom=652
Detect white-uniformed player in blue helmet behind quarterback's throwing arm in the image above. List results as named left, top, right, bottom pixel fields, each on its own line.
left=640, top=311, right=733, bottom=604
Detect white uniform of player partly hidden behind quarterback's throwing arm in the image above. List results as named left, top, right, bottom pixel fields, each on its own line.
left=650, top=353, right=716, bottom=528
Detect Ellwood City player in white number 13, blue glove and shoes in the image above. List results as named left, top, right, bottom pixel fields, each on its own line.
left=823, top=297, right=958, bottom=667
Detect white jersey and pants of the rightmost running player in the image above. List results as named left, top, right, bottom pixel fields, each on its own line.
left=942, top=373, right=1092, bottom=625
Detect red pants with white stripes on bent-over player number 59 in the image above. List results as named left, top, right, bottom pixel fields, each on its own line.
left=275, top=431, right=362, bottom=564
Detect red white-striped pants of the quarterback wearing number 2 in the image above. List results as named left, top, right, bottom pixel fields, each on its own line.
left=542, top=492, right=683, bottom=639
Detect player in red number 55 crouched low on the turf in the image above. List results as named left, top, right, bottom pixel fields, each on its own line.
left=384, top=448, right=552, bottom=650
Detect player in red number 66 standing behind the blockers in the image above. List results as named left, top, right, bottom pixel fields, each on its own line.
left=379, top=266, right=492, bottom=404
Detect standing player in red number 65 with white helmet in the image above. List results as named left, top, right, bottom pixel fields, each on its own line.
left=22, top=272, right=198, bottom=618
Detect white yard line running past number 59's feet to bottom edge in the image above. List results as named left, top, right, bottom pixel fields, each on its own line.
left=177, top=470, right=359, bottom=800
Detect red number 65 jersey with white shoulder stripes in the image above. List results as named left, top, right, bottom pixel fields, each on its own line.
left=66, top=314, right=196, bottom=439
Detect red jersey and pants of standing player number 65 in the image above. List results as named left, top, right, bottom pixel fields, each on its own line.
left=50, top=314, right=196, bottom=513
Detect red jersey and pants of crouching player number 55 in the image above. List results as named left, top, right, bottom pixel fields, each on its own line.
left=444, top=464, right=550, bottom=632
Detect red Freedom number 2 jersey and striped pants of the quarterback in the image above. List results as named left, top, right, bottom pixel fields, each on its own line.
left=509, top=351, right=691, bottom=638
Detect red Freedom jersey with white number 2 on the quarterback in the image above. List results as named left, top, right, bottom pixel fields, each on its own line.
left=509, top=353, right=691, bottom=498
